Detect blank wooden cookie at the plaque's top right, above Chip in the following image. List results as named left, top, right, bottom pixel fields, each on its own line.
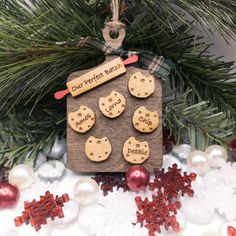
left=128, top=71, right=155, bottom=98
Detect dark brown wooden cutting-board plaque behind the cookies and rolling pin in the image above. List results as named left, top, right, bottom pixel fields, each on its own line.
left=67, top=61, right=162, bottom=172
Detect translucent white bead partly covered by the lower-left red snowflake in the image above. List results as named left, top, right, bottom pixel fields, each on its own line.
left=52, top=200, right=79, bottom=229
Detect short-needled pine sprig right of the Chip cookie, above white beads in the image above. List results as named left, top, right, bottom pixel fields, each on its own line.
left=163, top=91, right=236, bottom=150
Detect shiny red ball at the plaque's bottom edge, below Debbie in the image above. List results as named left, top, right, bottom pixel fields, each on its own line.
left=125, top=165, right=150, bottom=191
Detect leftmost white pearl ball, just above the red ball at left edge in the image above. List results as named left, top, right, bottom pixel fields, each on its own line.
left=8, top=164, right=34, bottom=190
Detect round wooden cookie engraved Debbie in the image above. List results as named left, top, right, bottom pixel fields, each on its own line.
left=123, top=137, right=150, bottom=164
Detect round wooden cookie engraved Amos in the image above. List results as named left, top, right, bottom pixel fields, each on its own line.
left=68, top=105, right=95, bottom=133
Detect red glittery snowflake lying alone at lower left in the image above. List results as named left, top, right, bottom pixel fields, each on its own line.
left=14, top=191, right=70, bottom=231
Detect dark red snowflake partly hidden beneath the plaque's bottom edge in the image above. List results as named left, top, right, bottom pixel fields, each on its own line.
left=92, top=173, right=129, bottom=196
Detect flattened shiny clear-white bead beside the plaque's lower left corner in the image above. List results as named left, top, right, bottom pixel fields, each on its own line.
left=38, top=160, right=66, bottom=182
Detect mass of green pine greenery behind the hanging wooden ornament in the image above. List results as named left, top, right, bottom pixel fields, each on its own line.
left=0, top=0, right=236, bottom=165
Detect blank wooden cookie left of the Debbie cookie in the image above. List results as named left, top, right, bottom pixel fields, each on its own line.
left=85, top=136, right=112, bottom=162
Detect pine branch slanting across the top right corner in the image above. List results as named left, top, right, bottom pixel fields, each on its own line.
left=143, top=0, right=236, bottom=39
